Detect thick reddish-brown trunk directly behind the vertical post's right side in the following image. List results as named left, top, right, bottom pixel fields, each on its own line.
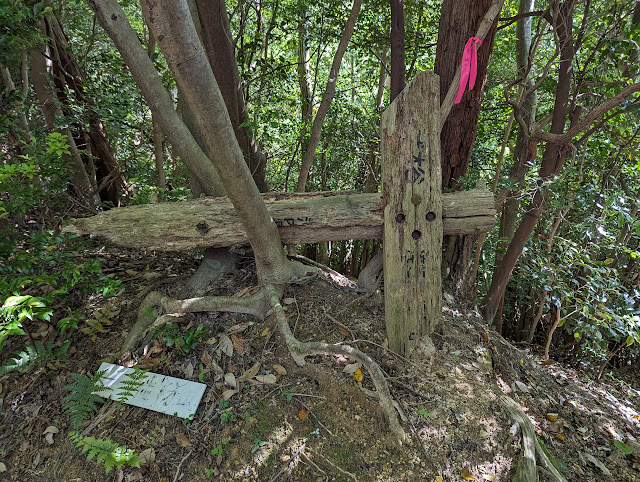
left=434, top=0, right=497, bottom=303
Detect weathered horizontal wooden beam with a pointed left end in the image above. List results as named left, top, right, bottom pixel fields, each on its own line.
left=63, top=189, right=495, bottom=251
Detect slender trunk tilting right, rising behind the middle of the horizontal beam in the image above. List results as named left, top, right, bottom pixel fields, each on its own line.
left=296, top=0, right=362, bottom=192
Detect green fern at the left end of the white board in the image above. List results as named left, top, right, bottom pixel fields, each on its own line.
left=63, top=370, right=111, bottom=430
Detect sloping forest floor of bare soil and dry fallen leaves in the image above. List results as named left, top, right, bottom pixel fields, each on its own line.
left=0, top=248, right=640, bottom=482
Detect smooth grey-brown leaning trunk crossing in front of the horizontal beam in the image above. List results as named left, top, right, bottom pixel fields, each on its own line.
left=140, top=0, right=290, bottom=284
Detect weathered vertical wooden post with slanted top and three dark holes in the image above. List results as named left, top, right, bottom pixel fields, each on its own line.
left=380, top=72, right=442, bottom=355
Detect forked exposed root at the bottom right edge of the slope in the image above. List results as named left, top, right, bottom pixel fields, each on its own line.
left=498, top=395, right=566, bottom=482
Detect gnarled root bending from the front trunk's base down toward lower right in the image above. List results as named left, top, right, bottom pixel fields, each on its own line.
left=265, top=285, right=407, bottom=443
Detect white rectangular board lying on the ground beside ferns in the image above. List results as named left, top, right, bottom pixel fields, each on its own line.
left=97, top=363, right=207, bottom=418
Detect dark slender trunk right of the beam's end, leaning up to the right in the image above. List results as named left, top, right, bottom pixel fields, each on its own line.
left=480, top=0, right=574, bottom=323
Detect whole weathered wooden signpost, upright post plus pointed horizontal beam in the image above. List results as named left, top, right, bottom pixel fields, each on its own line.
left=64, top=72, right=495, bottom=355
